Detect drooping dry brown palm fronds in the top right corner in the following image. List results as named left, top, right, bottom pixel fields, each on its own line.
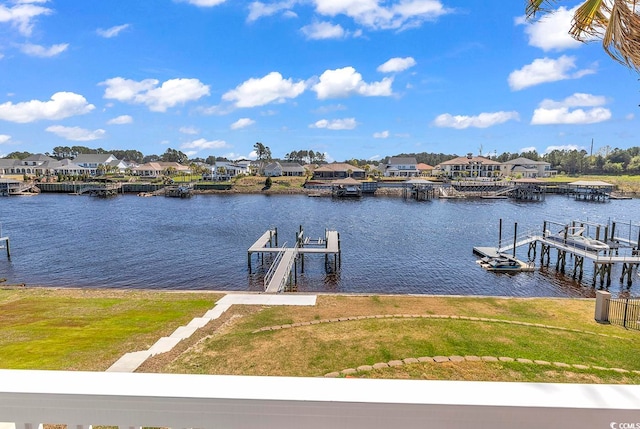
left=526, top=0, right=640, bottom=71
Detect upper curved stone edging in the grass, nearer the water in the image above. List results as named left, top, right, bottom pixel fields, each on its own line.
left=251, top=314, right=629, bottom=340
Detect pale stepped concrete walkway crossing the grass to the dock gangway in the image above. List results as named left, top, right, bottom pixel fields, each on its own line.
left=107, top=294, right=317, bottom=372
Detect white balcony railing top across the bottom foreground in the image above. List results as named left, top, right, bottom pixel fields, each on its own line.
left=0, top=368, right=640, bottom=429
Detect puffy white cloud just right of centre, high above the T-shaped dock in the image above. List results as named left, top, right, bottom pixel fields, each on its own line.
left=312, top=67, right=393, bottom=100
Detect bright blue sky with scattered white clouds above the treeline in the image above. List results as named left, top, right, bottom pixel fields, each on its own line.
left=0, top=0, right=640, bottom=161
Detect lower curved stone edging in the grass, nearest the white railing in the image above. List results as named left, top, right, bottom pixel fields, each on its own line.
left=324, top=355, right=640, bottom=378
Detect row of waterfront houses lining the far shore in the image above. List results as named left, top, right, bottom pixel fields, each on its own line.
left=0, top=154, right=556, bottom=181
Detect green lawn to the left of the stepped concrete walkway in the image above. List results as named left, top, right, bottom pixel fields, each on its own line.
left=0, top=289, right=220, bottom=371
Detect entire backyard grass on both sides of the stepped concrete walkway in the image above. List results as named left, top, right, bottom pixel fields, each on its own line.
left=0, top=288, right=640, bottom=384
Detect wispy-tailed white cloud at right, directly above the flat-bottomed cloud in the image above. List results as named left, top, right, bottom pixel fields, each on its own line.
left=508, top=55, right=595, bottom=91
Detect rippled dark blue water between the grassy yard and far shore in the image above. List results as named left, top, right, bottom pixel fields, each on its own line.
left=0, top=194, right=640, bottom=296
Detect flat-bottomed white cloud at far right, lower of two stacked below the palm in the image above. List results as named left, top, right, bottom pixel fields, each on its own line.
left=531, top=93, right=611, bottom=125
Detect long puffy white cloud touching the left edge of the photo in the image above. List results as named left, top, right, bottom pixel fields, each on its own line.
left=0, top=92, right=95, bottom=124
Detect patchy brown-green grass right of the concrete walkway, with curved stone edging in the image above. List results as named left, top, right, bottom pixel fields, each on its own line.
left=141, top=296, right=640, bottom=383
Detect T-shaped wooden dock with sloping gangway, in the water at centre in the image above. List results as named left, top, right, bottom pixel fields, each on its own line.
left=247, top=226, right=341, bottom=293
